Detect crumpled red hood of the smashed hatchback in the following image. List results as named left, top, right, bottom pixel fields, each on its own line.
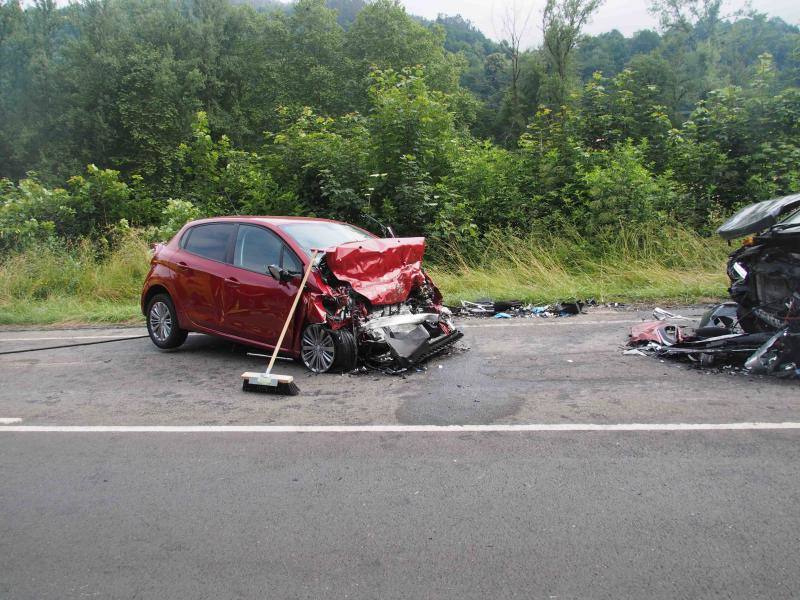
left=325, top=237, right=425, bottom=304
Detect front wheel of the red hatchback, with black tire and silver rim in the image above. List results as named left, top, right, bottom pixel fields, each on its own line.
left=300, top=323, right=358, bottom=373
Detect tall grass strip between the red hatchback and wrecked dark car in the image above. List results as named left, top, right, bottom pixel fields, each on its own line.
left=429, top=226, right=730, bottom=303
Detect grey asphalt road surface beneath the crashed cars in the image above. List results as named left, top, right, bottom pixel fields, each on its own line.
left=0, top=310, right=800, bottom=599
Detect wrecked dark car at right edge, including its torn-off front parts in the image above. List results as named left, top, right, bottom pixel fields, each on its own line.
left=628, top=194, right=800, bottom=378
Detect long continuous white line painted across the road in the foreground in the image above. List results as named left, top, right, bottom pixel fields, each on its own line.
left=0, top=422, right=800, bottom=433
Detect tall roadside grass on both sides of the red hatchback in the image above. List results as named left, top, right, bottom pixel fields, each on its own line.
left=0, top=227, right=729, bottom=325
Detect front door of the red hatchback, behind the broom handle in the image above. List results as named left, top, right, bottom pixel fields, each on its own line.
left=222, top=224, right=303, bottom=349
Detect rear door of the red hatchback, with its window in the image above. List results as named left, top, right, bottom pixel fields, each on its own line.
left=174, top=223, right=236, bottom=331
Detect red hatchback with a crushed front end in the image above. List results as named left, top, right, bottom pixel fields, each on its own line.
left=141, top=217, right=462, bottom=373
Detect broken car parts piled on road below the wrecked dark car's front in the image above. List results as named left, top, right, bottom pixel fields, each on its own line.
left=625, top=304, right=800, bottom=378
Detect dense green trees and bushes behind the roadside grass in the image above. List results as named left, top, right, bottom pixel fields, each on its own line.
left=0, top=0, right=800, bottom=255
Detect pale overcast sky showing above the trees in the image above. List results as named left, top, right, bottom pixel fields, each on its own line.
left=401, top=0, right=800, bottom=45
